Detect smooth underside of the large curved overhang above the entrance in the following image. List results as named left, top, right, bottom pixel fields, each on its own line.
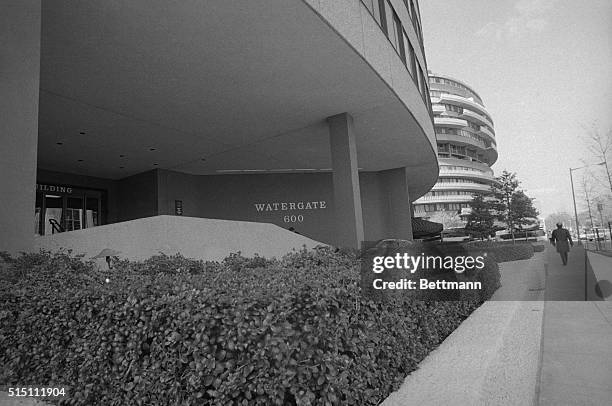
left=39, top=0, right=437, bottom=196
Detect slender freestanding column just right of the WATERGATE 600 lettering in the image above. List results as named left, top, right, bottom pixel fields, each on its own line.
left=327, top=113, right=364, bottom=248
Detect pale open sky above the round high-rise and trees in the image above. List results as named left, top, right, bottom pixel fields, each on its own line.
left=419, top=0, right=612, bottom=217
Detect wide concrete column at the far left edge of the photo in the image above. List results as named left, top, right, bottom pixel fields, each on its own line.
left=0, top=0, right=41, bottom=253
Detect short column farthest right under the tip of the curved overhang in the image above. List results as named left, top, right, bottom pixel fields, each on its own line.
left=378, top=168, right=412, bottom=240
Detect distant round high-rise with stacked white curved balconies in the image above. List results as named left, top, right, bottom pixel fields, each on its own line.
left=414, top=73, right=497, bottom=228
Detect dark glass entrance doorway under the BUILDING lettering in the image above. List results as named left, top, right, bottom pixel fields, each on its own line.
left=34, top=184, right=103, bottom=235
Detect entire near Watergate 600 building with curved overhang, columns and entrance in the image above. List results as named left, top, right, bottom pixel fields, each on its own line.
left=0, top=0, right=438, bottom=252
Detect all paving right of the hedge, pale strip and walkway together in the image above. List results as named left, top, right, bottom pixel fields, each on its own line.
left=383, top=245, right=612, bottom=406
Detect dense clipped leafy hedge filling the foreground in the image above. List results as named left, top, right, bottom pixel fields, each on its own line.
left=0, top=248, right=498, bottom=405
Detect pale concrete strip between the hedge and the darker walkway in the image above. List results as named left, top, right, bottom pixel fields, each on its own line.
left=382, top=253, right=545, bottom=406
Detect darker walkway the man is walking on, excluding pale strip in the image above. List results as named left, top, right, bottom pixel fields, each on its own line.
left=537, top=246, right=612, bottom=406
